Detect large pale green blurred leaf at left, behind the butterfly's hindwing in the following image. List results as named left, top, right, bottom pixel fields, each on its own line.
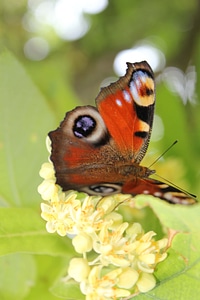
left=0, top=52, right=55, bottom=206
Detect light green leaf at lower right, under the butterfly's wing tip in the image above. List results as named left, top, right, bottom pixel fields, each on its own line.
left=134, top=197, right=200, bottom=300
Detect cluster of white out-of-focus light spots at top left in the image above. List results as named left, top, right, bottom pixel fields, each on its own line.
left=22, top=0, right=108, bottom=60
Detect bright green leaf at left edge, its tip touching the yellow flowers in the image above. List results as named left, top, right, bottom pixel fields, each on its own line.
left=0, top=208, right=72, bottom=258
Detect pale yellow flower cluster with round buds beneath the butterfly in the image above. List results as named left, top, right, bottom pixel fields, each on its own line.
left=38, top=137, right=168, bottom=300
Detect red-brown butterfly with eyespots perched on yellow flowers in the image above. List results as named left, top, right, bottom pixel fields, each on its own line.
left=49, top=61, right=196, bottom=205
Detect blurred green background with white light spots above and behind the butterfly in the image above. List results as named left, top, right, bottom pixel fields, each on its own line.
left=0, top=0, right=200, bottom=193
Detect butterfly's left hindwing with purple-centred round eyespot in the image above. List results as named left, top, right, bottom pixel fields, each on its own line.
left=49, top=106, right=113, bottom=190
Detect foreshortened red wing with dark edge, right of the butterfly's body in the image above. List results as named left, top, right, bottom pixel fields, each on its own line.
left=122, top=178, right=196, bottom=205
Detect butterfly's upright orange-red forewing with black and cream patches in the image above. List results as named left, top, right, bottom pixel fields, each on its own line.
left=96, top=62, right=155, bottom=163
